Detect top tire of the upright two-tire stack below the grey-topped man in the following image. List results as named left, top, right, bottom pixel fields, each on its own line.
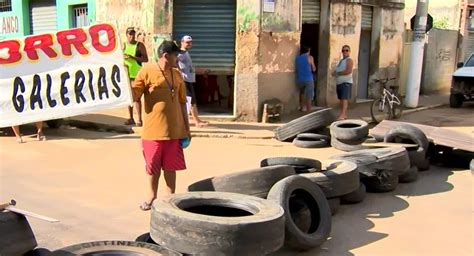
left=329, top=119, right=369, bottom=141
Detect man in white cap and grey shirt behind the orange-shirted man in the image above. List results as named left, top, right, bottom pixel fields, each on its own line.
left=178, top=35, right=208, bottom=127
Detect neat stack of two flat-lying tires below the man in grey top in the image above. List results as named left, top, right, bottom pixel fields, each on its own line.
left=329, top=119, right=369, bottom=151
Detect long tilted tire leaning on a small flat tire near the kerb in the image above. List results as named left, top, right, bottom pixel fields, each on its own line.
left=275, top=108, right=336, bottom=141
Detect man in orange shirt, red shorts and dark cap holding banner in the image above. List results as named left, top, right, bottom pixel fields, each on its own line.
left=132, top=41, right=191, bottom=211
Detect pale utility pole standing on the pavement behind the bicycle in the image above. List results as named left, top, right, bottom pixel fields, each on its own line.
left=405, top=0, right=429, bottom=108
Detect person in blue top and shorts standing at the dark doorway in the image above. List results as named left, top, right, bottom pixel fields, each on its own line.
left=296, top=46, right=316, bottom=112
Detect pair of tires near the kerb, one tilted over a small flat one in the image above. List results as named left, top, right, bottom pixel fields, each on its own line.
left=275, top=108, right=335, bottom=148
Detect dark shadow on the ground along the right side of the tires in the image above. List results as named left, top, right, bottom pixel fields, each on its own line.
left=272, top=166, right=453, bottom=256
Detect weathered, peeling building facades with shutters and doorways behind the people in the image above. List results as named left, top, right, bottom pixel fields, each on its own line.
left=0, top=0, right=404, bottom=121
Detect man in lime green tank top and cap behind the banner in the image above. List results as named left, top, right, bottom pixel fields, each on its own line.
left=123, top=27, right=148, bottom=126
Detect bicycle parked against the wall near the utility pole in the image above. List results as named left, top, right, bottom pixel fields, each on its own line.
left=370, top=78, right=403, bottom=123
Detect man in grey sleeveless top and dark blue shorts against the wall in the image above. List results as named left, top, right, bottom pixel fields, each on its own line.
left=334, top=45, right=354, bottom=120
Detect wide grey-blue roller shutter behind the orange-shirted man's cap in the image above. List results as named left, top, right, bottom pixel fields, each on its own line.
left=173, top=0, right=236, bottom=74
